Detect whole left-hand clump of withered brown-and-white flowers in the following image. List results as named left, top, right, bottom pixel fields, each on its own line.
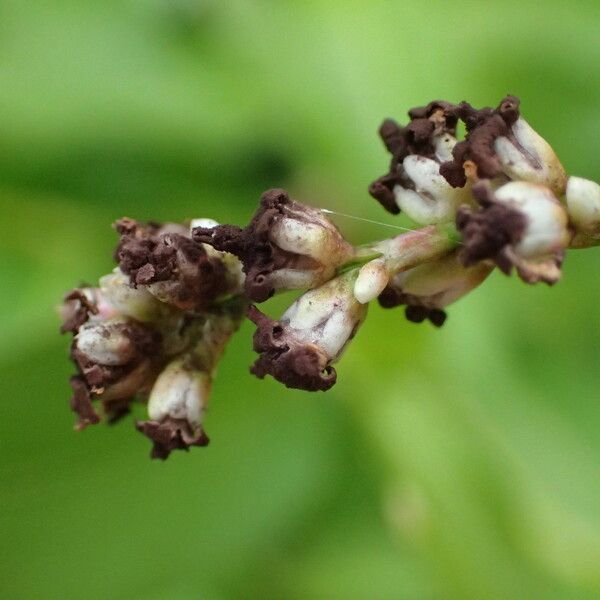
left=61, top=219, right=245, bottom=458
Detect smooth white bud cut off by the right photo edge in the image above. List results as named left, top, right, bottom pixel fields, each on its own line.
left=566, top=177, right=600, bottom=248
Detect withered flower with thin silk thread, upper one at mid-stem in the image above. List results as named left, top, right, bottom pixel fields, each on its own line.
left=193, top=189, right=354, bottom=302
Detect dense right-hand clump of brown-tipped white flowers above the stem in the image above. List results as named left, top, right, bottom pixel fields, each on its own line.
left=370, top=96, right=600, bottom=290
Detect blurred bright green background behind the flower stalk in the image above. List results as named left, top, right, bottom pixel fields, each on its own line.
left=0, top=0, right=600, bottom=600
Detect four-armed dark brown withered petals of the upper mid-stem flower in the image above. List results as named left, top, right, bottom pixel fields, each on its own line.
left=193, top=189, right=324, bottom=302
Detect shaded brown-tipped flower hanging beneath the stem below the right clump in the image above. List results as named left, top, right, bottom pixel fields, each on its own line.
left=379, top=251, right=493, bottom=327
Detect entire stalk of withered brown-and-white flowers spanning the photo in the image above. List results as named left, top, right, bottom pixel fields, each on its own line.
left=61, top=96, right=600, bottom=459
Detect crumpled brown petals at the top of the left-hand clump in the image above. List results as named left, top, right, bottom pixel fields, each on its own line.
left=115, top=219, right=227, bottom=310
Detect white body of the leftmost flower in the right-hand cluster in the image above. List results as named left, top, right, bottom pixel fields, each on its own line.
left=394, top=155, right=470, bottom=225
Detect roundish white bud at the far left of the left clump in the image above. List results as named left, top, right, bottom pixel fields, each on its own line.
left=75, top=319, right=136, bottom=366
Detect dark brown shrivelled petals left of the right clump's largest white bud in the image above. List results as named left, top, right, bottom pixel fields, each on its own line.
left=456, top=181, right=527, bottom=273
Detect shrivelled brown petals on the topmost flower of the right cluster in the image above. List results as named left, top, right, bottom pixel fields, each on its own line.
left=440, top=96, right=520, bottom=187
